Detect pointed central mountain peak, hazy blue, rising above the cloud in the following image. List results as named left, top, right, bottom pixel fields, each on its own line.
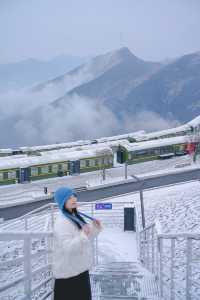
left=53, top=48, right=162, bottom=106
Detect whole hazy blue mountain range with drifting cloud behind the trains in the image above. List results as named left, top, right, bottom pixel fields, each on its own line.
left=0, top=48, right=200, bottom=146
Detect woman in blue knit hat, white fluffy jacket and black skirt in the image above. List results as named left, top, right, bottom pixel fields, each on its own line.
left=53, top=187, right=101, bottom=300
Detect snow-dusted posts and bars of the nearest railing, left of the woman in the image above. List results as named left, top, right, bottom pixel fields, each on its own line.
left=0, top=231, right=53, bottom=300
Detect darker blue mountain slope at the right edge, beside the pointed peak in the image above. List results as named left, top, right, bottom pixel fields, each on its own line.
left=124, top=52, right=200, bottom=123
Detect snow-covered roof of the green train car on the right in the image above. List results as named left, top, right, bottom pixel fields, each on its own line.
left=121, top=136, right=188, bottom=151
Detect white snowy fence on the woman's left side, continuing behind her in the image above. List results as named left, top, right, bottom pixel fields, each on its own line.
left=0, top=202, right=134, bottom=300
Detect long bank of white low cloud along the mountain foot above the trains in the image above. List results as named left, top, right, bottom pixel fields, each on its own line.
left=0, top=95, right=179, bottom=148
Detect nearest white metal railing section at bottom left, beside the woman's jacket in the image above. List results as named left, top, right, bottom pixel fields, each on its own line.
left=0, top=232, right=53, bottom=300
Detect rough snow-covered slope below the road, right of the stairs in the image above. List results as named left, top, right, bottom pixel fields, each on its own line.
left=101, top=181, right=200, bottom=233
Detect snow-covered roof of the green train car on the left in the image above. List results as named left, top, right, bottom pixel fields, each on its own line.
left=0, top=146, right=112, bottom=169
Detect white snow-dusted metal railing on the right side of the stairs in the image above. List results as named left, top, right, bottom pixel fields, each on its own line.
left=140, top=224, right=200, bottom=300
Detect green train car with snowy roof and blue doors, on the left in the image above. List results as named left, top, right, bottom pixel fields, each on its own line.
left=0, top=145, right=113, bottom=185
